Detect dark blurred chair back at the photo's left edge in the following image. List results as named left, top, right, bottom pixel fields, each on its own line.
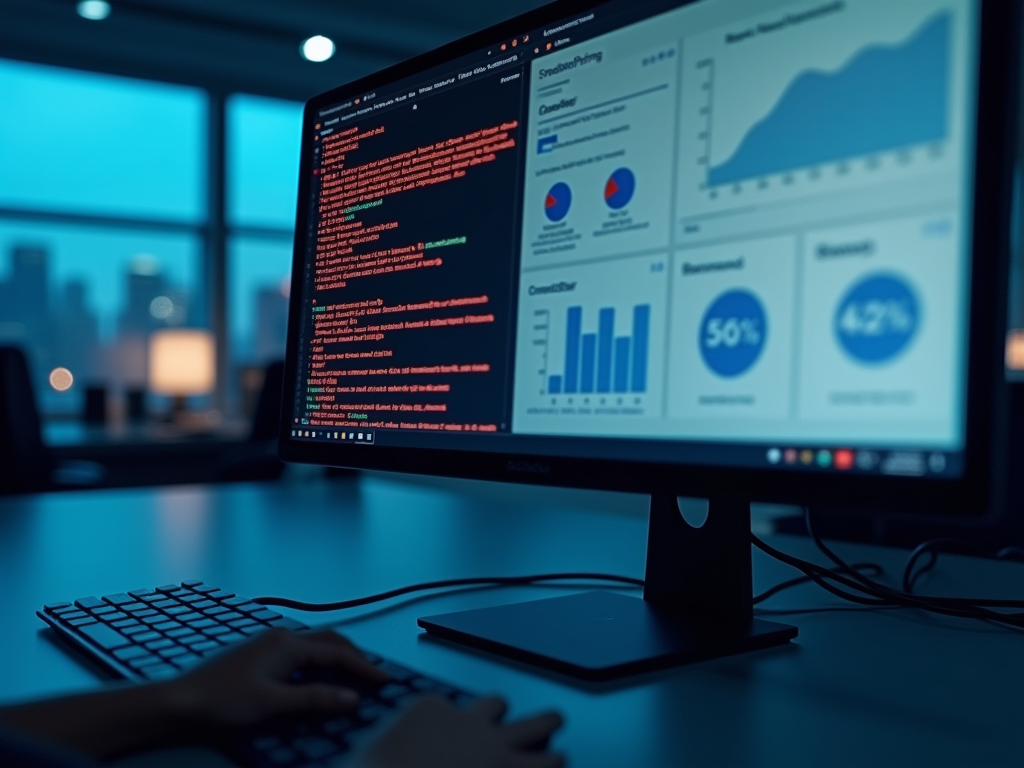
left=0, top=347, right=53, bottom=494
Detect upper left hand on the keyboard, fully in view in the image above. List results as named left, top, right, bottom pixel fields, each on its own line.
left=163, top=629, right=388, bottom=726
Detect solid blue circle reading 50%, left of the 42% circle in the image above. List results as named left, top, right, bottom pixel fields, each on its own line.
left=699, top=289, right=768, bottom=379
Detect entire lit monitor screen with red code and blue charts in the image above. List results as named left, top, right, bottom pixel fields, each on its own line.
left=292, top=0, right=979, bottom=474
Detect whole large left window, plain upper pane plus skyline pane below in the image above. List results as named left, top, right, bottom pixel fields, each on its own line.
left=0, top=60, right=208, bottom=416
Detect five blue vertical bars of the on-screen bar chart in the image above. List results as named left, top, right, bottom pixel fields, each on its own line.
left=547, top=304, right=650, bottom=394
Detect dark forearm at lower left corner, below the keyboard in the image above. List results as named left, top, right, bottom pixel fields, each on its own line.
left=0, top=683, right=198, bottom=758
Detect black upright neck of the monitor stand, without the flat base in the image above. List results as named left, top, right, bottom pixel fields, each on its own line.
left=643, top=494, right=754, bottom=628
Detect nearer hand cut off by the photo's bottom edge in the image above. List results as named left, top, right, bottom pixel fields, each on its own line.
left=358, top=696, right=564, bottom=768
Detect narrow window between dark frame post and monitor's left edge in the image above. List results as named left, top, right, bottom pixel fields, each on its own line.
left=226, top=94, right=302, bottom=413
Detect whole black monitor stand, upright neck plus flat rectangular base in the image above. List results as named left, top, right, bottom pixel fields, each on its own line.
left=418, top=494, right=797, bottom=680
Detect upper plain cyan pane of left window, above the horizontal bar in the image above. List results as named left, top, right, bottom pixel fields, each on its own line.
left=0, top=60, right=207, bottom=222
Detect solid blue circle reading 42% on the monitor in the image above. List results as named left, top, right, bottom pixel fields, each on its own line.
left=835, top=274, right=921, bottom=365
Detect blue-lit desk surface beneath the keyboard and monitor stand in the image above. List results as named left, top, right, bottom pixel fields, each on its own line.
left=0, top=476, right=1024, bottom=768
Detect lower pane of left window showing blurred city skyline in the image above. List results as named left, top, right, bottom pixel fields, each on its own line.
left=0, top=220, right=206, bottom=415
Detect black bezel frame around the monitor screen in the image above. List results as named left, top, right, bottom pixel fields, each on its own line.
left=279, top=0, right=1020, bottom=516
